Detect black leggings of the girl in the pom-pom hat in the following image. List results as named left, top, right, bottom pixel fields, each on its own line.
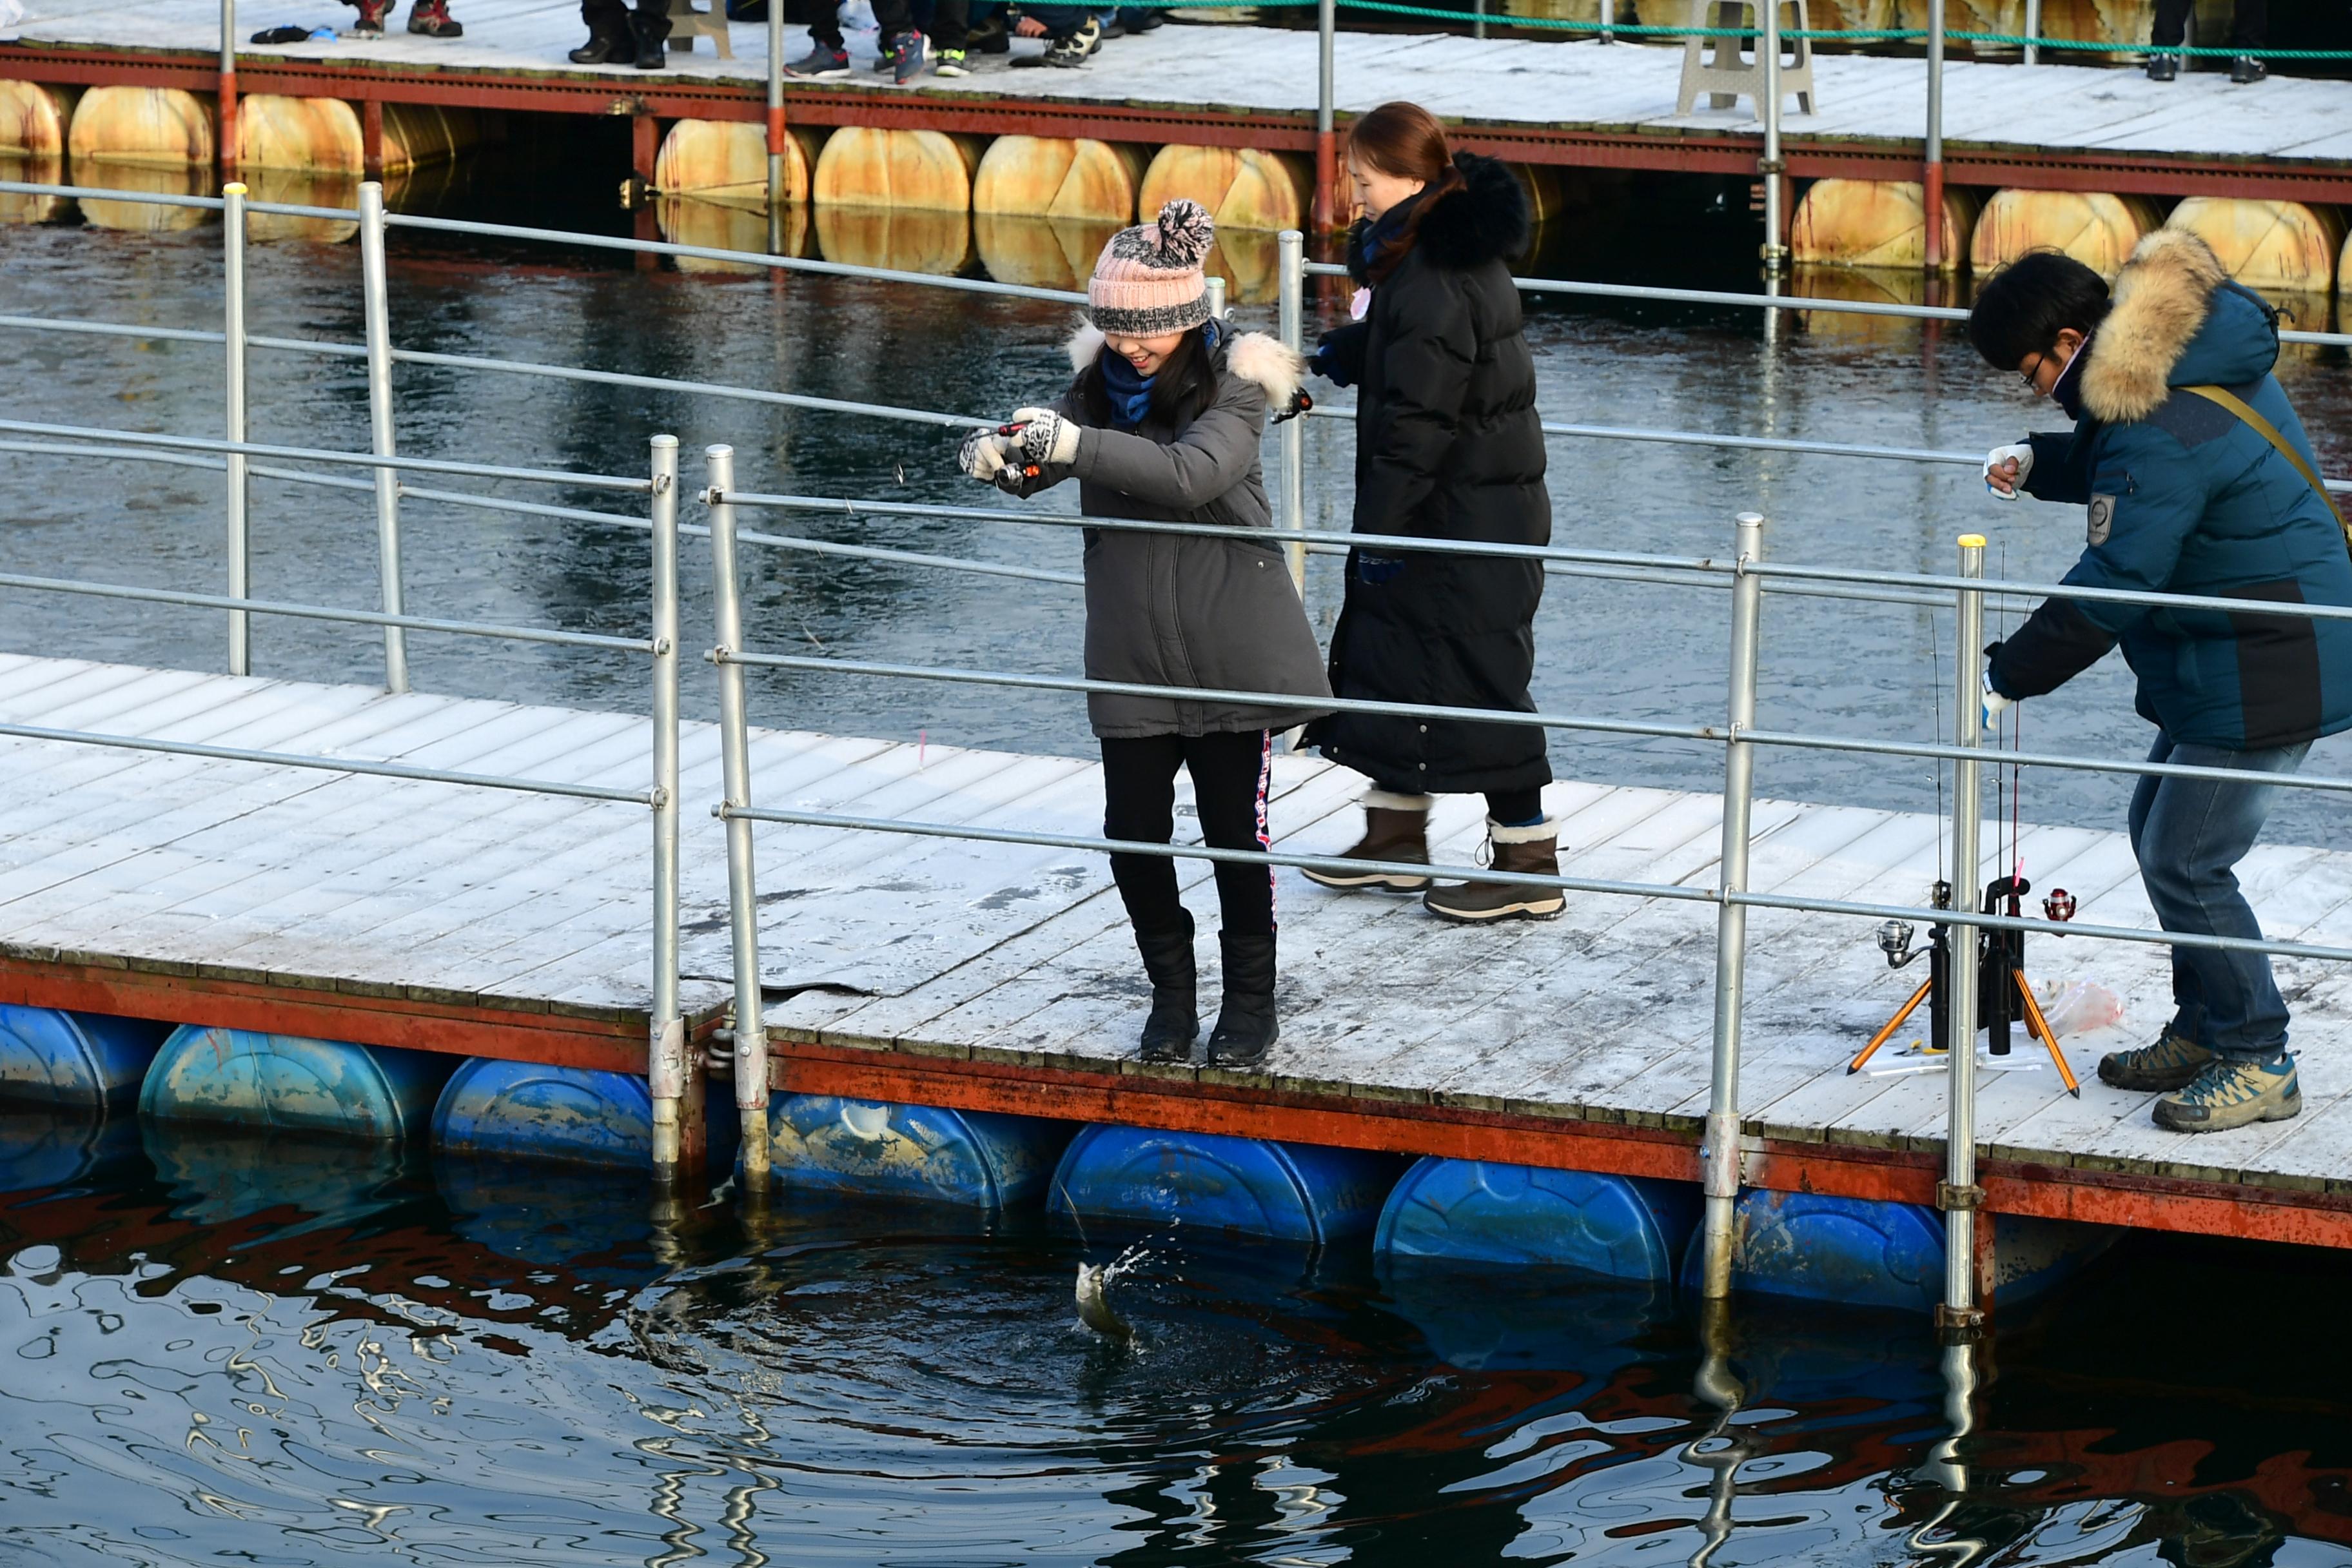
left=1103, top=729, right=1275, bottom=936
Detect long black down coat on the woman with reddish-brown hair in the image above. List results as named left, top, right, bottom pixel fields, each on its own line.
left=1308, top=153, right=1553, bottom=794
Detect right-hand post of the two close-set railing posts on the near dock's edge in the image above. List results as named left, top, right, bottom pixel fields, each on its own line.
left=703, top=447, right=769, bottom=1192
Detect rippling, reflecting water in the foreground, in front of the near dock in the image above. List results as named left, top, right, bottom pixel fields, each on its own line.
left=0, top=1119, right=2352, bottom=1568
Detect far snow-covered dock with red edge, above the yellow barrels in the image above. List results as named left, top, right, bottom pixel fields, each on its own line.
left=0, top=0, right=2352, bottom=202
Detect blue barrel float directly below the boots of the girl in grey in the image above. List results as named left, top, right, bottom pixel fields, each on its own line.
left=1046, top=1126, right=1402, bottom=1246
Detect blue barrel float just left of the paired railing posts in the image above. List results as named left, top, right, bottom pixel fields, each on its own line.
left=433, top=1055, right=741, bottom=1171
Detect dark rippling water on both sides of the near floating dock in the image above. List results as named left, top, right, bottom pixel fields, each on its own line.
left=0, top=172, right=2352, bottom=1568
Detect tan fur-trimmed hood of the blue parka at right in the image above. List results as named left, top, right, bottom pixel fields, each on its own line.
left=2081, top=228, right=2279, bottom=426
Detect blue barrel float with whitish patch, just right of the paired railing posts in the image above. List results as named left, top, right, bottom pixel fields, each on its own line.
left=767, top=1095, right=1070, bottom=1208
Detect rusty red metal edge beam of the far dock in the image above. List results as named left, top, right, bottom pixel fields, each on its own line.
left=18, top=44, right=2352, bottom=202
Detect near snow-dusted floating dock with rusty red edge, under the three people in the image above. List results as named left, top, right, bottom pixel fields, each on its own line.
left=0, top=656, right=2352, bottom=1246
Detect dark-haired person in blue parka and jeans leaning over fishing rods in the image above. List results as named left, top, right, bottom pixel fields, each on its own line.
left=1968, top=228, right=2352, bottom=1133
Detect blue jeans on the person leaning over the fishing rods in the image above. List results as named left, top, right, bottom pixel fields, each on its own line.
left=2131, top=731, right=2312, bottom=1060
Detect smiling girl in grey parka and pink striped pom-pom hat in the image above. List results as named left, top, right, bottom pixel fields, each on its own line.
left=962, top=202, right=1331, bottom=1067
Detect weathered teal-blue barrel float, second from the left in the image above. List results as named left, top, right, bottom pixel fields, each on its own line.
left=139, top=1025, right=456, bottom=1140
